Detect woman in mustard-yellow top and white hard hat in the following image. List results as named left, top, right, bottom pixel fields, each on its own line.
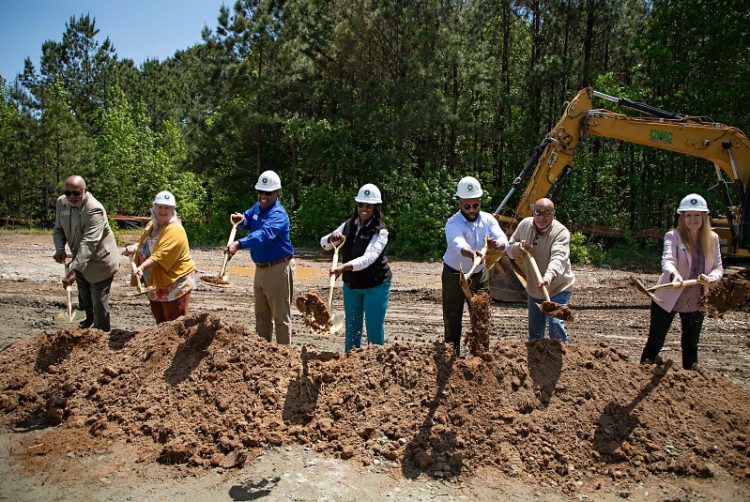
left=123, top=191, right=195, bottom=324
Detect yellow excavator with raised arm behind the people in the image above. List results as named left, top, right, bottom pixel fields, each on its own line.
left=490, top=87, right=750, bottom=302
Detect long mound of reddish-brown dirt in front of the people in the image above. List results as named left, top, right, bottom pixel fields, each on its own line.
left=0, top=314, right=750, bottom=492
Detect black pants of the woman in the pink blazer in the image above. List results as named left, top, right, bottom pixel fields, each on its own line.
left=641, top=302, right=703, bottom=369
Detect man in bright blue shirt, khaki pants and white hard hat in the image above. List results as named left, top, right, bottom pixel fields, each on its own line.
left=226, top=171, right=295, bottom=344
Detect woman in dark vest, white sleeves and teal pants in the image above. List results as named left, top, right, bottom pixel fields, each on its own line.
left=320, top=183, right=392, bottom=352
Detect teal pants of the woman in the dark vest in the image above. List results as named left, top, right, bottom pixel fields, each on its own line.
left=344, top=281, right=391, bottom=352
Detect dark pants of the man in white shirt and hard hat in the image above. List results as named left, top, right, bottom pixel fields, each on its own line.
left=441, top=263, right=490, bottom=355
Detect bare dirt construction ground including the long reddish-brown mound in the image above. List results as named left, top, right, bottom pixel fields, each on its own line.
left=0, top=232, right=750, bottom=501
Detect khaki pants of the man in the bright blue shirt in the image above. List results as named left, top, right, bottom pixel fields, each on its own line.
left=253, top=258, right=296, bottom=344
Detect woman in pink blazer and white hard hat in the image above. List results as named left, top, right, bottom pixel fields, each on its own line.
left=641, top=193, right=724, bottom=369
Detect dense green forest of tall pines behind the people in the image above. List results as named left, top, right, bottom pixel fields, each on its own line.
left=0, top=0, right=750, bottom=262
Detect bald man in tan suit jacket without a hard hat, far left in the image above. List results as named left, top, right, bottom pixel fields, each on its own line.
left=52, top=176, right=120, bottom=331
